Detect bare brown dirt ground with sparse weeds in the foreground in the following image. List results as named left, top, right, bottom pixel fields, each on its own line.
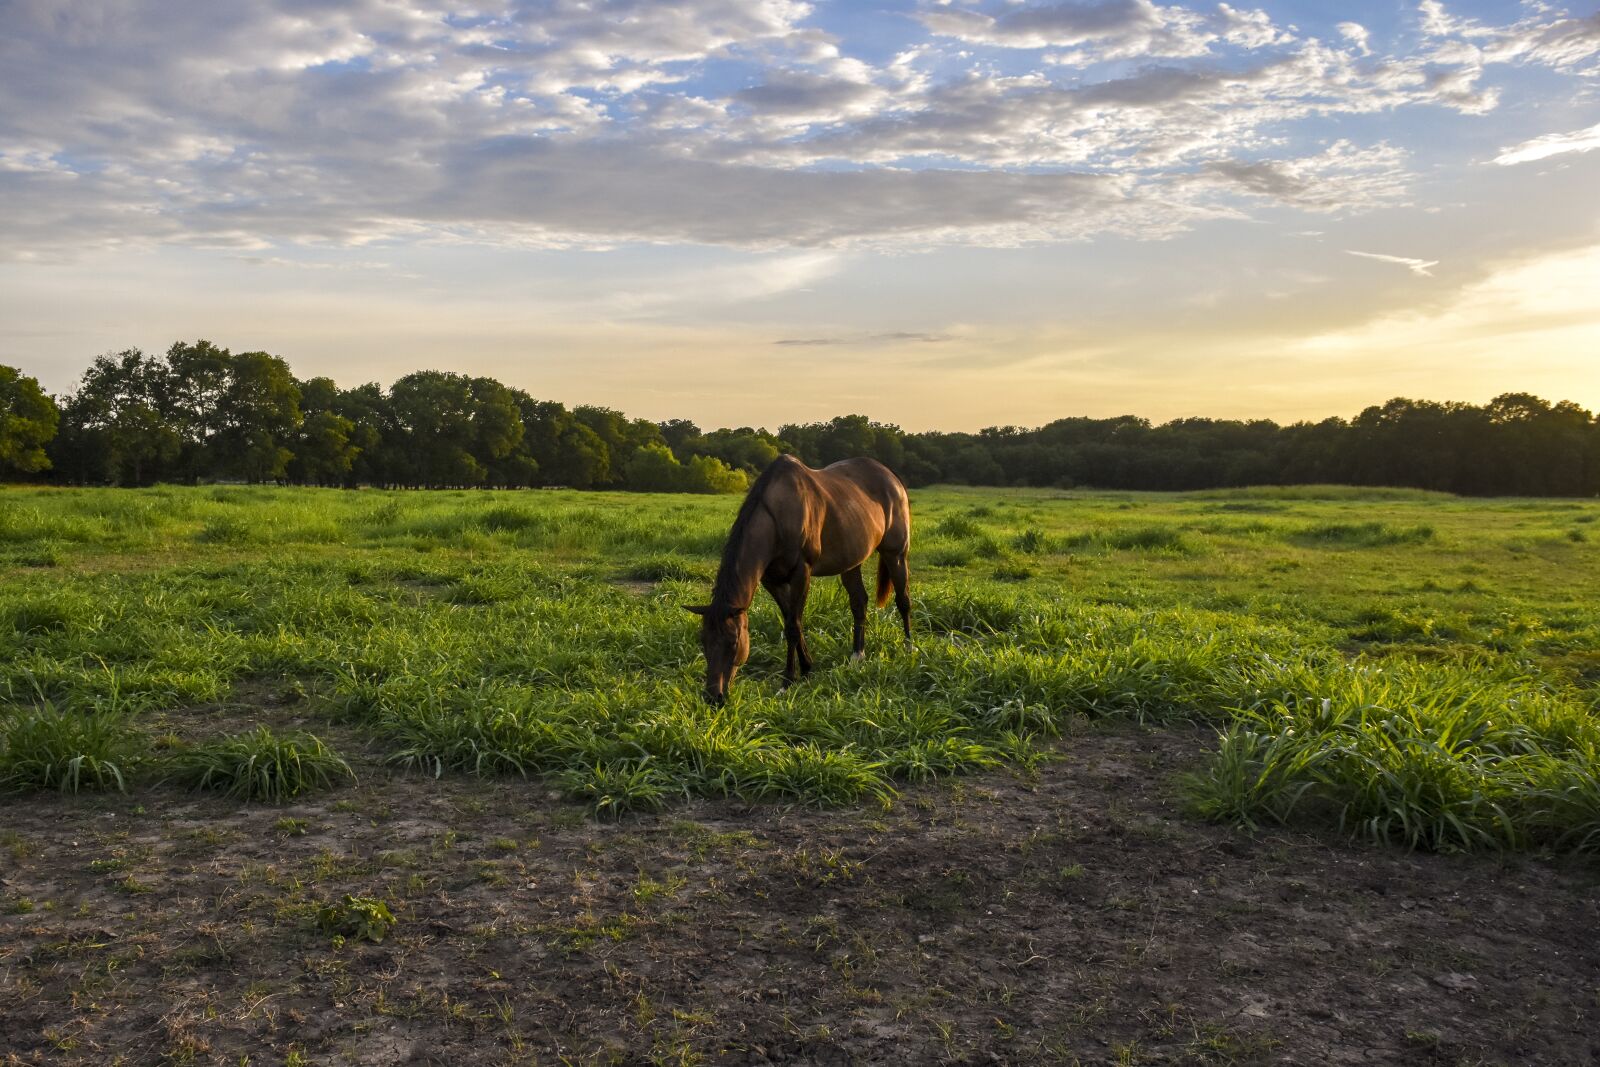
left=0, top=717, right=1600, bottom=1064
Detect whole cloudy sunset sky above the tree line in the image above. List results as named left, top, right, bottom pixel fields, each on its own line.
left=0, top=0, right=1600, bottom=430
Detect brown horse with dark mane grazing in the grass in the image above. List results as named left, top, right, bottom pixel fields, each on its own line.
left=690, top=456, right=910, bottom=705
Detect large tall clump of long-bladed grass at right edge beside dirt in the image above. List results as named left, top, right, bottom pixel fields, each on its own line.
left=1187, top=669, right=1600, bottom=851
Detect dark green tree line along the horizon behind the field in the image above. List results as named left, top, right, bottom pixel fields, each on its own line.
left=0, top=341, right=1600, bottom=496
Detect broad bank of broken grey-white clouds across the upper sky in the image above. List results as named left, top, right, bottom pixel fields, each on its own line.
left=0, top=0, right=1600, bottom=261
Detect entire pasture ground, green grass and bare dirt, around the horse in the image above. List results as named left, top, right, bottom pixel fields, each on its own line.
left=0, top=486, right=1600, bottom=1062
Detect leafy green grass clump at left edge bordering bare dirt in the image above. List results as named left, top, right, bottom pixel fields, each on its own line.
left=0, top=704, right=142, bottom=793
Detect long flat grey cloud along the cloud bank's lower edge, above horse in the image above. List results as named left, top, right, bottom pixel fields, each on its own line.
left=416, top=139, right=1152, bottom=248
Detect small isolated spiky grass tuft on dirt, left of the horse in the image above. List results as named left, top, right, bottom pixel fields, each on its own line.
left=171, top=726, right=355, bottom=801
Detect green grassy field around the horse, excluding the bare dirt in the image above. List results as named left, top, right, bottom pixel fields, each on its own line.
left=9, top=486, right=1600, bottom=851
